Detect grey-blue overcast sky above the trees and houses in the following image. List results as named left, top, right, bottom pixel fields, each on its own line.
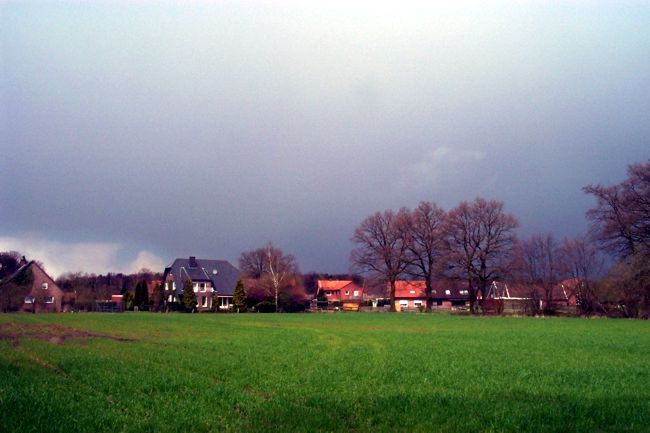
left=0, top=0, right=650, bottom=275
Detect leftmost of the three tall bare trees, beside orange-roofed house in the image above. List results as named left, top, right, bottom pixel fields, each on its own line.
left=350, top=209, right=409, bottom=311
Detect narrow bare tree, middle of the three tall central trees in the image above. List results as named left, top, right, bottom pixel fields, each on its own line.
left=407, top=201, right=446, bottom=311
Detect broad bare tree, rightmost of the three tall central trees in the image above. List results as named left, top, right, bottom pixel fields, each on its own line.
left=445, top=198, right=519, bottom=312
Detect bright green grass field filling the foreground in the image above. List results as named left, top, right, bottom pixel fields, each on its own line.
left=0, top=313, right=650, bottom=432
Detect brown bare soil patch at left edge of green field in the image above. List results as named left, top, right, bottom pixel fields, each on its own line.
left=0, top=323, right=134, bottom=347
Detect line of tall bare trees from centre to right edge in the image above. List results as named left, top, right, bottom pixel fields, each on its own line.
left=350, top=157, right=650, bottom=317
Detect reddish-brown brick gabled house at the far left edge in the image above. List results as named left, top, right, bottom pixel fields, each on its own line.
left=2, top=258, right=64, bottom=313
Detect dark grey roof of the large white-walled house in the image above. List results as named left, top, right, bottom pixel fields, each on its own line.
left=163, top=257, right=239, bottom=295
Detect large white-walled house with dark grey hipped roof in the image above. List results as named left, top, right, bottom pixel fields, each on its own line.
left=162, top=256, right=239, bottom=311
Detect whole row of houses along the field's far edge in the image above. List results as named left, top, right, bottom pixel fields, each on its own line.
left=2, top=256, right=578, bottom=312
